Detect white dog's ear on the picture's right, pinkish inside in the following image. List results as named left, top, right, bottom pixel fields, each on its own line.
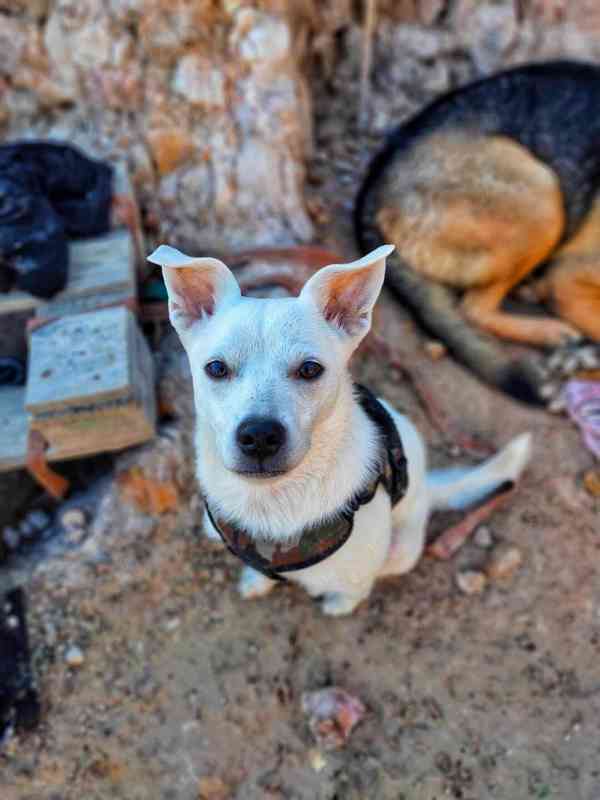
left=300, top=244, right=394, bottom=339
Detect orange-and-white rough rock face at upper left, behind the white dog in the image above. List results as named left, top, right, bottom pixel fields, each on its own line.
left=0, top=0, right=312, bottom=248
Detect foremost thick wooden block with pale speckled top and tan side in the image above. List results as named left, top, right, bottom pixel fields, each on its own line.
left=25, top=306, right=156, bottom=461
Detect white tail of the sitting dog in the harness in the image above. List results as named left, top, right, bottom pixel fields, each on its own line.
left=427, top=433, right=531, bottom=510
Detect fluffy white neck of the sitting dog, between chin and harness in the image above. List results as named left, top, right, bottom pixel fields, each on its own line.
left=196, top=377, right=379, bottom=539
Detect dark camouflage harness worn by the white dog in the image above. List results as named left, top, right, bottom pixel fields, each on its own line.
left=206, top=384, right=408, bottom=581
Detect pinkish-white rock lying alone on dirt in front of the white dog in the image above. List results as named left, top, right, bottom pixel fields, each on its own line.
left=302, top=686, right=366, bottom=750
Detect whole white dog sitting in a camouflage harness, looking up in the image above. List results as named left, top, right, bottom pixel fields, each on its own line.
left=149, top=245, right=530, bottom=615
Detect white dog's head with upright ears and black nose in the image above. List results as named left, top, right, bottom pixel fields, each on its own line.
left=149, top=245, right=393, bottom=481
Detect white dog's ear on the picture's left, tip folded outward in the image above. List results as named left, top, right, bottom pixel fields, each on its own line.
left=148, top=244, right=241, bottom=338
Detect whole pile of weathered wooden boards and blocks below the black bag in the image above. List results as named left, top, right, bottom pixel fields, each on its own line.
left=0, top=162, right=151, bottom=472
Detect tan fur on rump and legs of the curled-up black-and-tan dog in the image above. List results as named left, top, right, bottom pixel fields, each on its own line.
left=376, top=133, right=600, bottom=345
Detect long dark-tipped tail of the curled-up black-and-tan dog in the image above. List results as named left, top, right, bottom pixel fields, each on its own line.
left=354, top=163, right=544, bottom=406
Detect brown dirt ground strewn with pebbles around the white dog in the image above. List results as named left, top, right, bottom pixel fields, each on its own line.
left=0, top=15, right=600, bottom=800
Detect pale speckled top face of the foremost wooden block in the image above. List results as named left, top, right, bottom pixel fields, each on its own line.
left=25, top=306, right=135, bottom=415
